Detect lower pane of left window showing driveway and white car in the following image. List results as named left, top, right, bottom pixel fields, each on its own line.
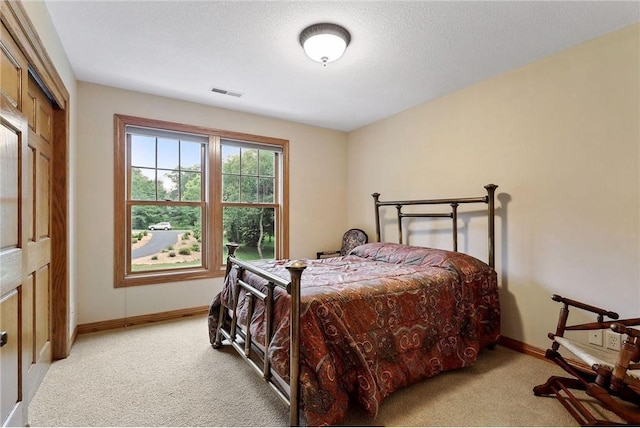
left=130, top=205, right=202, bottom=272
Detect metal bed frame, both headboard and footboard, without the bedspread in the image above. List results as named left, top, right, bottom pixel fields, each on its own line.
left=213, top=184, right=498, bottom=426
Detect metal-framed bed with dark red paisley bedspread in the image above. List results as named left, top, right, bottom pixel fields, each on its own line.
left=209, top=185, right=500, bottom=426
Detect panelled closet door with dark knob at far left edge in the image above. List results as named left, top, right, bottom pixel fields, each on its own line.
left=0, top=20, right=30, bottom=425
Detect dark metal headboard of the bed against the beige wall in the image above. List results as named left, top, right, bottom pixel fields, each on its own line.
left=371, top=184, right=498, bottom=268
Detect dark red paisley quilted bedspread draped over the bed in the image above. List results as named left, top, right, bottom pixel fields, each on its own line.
left=209, top=243, right=500, bottom=426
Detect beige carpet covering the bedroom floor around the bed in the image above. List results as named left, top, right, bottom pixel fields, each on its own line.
left=29, top=317, right=624, bottom=426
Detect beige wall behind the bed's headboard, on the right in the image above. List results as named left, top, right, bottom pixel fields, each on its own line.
left=348, top=25, right=640, bottom=348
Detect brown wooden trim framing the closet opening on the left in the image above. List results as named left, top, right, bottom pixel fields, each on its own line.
left=0, top=0, right=72, bottom=360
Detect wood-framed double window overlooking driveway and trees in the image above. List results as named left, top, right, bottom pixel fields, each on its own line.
left=115, top=115, right=288, bottom=287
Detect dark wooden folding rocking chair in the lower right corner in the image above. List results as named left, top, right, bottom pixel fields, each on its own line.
left=533, top=295, right=640, bottom=426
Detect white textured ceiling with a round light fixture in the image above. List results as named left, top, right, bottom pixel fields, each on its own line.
left=45, top=0, right=640, bottom=131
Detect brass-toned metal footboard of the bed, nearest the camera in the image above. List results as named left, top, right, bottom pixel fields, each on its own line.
left=213, top=243, right=306, bottom=426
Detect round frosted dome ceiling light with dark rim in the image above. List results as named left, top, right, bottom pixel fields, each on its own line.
left=300, top=23, right=351, bottom=67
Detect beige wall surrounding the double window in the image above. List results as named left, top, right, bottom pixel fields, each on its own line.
left=76, top=82, right=347, bottom=324
